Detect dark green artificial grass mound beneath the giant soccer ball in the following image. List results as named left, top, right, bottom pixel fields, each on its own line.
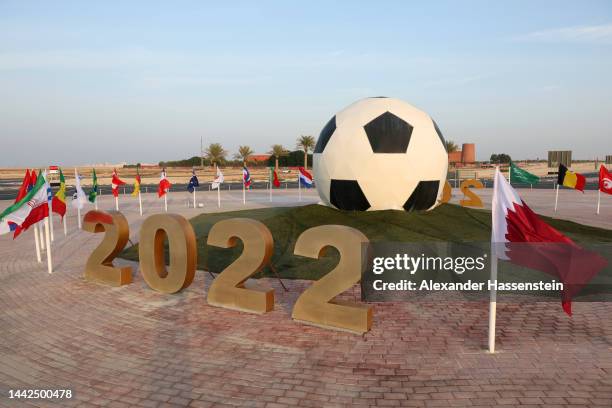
left=120, top=204, right=612, bottom=280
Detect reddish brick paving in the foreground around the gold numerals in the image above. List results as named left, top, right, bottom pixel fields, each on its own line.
left=0, top=192, right=612, bottom=407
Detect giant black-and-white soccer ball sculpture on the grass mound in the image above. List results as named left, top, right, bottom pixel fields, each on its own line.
left=313, top=97, right=448, bottom=211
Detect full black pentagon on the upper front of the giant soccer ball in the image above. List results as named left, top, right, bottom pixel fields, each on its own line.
left=363, top=112, right=413, bottom=153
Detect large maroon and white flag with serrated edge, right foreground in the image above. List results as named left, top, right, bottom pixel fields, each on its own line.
left=491, top=168, right=607, bottom=316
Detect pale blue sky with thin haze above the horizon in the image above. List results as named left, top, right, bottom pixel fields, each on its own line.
left=0, top=0, right=612, bottom=167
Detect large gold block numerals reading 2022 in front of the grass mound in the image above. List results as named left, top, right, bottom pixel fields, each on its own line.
left=83, top=210, right=372, bottom=333
